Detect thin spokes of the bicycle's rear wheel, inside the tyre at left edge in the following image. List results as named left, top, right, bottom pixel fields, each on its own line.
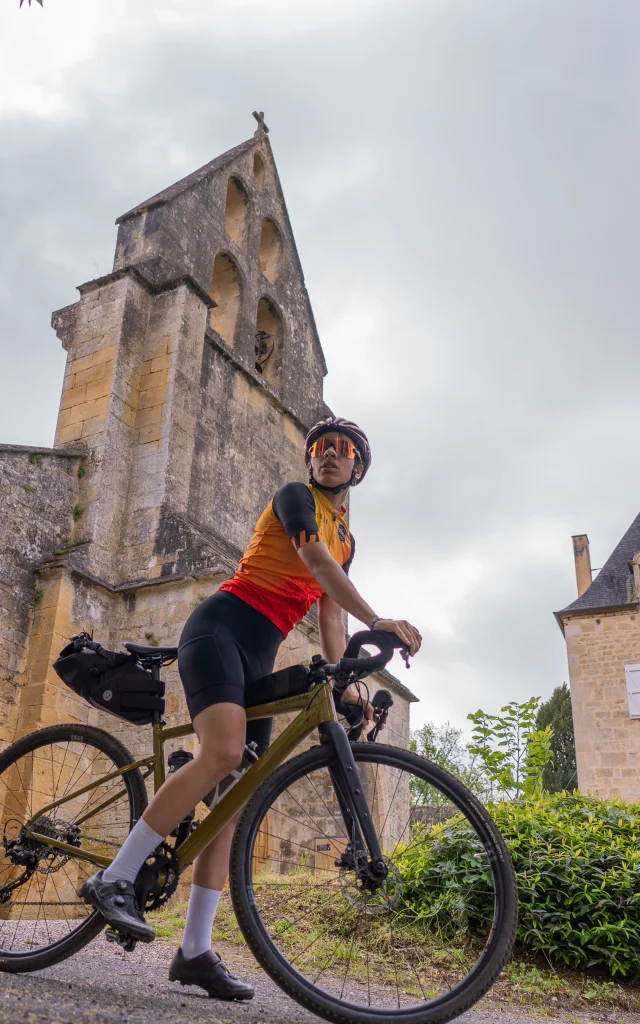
left=0, top=726, right=140, bottom=968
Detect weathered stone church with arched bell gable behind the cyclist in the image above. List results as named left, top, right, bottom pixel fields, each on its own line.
left=0, top=120, right=416, bottom=753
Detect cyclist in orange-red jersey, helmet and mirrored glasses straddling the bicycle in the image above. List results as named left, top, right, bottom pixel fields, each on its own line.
left=81, top=417, right=422, bottom=999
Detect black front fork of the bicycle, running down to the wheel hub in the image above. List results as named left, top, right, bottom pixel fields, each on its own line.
left=318, top=722, right=388, bottom=880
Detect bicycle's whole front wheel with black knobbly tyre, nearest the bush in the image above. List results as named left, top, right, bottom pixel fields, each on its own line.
left=230, top=743, right=517, bottom=1024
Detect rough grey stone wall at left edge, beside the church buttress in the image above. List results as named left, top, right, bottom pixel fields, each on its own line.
left=0, top=444, right=81, bottom=748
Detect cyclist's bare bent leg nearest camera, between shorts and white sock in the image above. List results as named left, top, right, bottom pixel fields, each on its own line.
left=142, top=703, right=247, bottom=839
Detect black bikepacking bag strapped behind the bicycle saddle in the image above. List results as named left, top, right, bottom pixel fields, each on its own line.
left=53, top=634, right=165, bottom=725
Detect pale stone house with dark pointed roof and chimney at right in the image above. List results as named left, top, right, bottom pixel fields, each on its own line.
left=555, top=515, right=640, bottom=801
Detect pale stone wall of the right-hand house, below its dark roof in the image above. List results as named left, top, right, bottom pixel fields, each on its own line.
left=563, top=610, right=640, bottom=801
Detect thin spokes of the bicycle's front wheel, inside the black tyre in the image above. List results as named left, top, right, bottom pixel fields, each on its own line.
left=239, top=744, right=514, bottom=1024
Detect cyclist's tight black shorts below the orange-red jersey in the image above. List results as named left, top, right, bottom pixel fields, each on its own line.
left=178, top=591, right=285, bottom=756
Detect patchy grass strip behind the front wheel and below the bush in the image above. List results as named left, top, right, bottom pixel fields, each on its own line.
left=148, top=870, right=640, bottom=1016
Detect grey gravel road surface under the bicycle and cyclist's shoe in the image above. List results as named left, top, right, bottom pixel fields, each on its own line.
left=0, top=937, right=640, bottom=1024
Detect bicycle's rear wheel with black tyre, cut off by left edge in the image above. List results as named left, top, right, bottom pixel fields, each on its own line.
left=0, top=725, right=146, bottom=972
